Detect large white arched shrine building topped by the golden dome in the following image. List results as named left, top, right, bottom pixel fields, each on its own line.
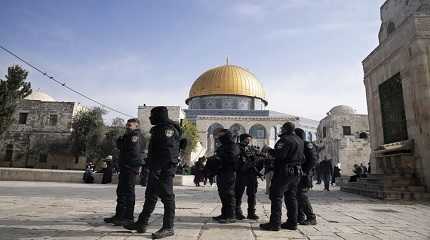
left=139, top=64, right=318, bottom=165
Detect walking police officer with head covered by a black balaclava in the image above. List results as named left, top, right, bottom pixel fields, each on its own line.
left=124, top=106, right=181, bottom=239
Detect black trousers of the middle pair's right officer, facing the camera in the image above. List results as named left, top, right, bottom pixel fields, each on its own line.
left=235, top=173, right=258, bottom=215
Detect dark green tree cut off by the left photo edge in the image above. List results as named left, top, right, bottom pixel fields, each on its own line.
left=0, top=65, right=31, bottom=135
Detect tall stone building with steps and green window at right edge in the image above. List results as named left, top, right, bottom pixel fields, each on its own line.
left=342, top=0, right=430, bottom=199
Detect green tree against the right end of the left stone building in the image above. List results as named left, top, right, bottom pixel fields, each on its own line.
left=72, top=107, right=106, bottom=160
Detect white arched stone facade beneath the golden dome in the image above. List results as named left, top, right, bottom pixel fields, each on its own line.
left=138, top=106, right=318, bottom=162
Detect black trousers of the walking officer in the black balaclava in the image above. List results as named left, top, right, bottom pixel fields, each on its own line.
left=138, top=167, right=176, bottom=228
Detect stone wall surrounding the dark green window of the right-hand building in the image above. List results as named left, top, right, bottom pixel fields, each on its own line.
left=363, top=1, right=430, bottom=187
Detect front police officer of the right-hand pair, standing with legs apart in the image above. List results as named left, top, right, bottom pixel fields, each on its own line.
left=260, top=122, right=304, bottom=231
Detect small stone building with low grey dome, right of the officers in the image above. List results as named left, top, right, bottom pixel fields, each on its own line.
left=317, top=106, right=370, bottom=175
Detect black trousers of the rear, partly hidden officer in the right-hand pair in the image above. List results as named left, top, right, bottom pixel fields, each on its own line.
left=297, top=176, right=316, bottom=222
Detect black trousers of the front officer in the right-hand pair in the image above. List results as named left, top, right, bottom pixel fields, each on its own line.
left=270, top=172, right=299, bottom=227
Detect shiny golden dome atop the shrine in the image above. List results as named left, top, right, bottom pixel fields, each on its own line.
left=186, top=65, right=267, bottom=105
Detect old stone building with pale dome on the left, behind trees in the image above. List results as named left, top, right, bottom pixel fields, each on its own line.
left=0, top=91, right=85, bottom=169
